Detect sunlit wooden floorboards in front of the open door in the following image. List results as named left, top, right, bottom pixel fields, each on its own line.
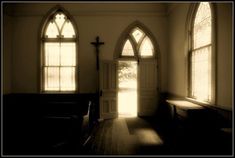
left=86, top=118, right=163, bottom=155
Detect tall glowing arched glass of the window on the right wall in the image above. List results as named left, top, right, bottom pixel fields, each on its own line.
left=190, top=2, right=212, bottom=102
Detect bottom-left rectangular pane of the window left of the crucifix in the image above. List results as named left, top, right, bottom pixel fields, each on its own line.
left=44, top=67, right=59, bottom=91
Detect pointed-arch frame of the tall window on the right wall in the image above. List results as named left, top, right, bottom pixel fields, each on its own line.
left=186, top=2, right=217, bottom=106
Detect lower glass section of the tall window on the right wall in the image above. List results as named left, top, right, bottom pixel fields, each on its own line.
left=191, top=46, right=211, bottom=101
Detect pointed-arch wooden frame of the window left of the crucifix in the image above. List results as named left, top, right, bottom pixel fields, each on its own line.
left=39, top=6, right=79, bottom=93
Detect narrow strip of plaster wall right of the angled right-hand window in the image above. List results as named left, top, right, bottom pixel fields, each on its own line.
left=217, top=3, right=234, bottom=109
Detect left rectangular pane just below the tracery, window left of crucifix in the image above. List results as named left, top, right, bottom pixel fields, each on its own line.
left=45, top=43, right=60, bottom=66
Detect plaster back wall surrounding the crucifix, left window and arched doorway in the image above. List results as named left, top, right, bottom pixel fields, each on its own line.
left=4, top=3, right=167, bottom=93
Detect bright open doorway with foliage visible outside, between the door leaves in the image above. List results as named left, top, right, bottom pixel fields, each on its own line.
left=118, top=61, right=137, bottom=117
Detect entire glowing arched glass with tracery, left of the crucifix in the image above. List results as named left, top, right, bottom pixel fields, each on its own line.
left=42, top=10, right=77, bottom=92
